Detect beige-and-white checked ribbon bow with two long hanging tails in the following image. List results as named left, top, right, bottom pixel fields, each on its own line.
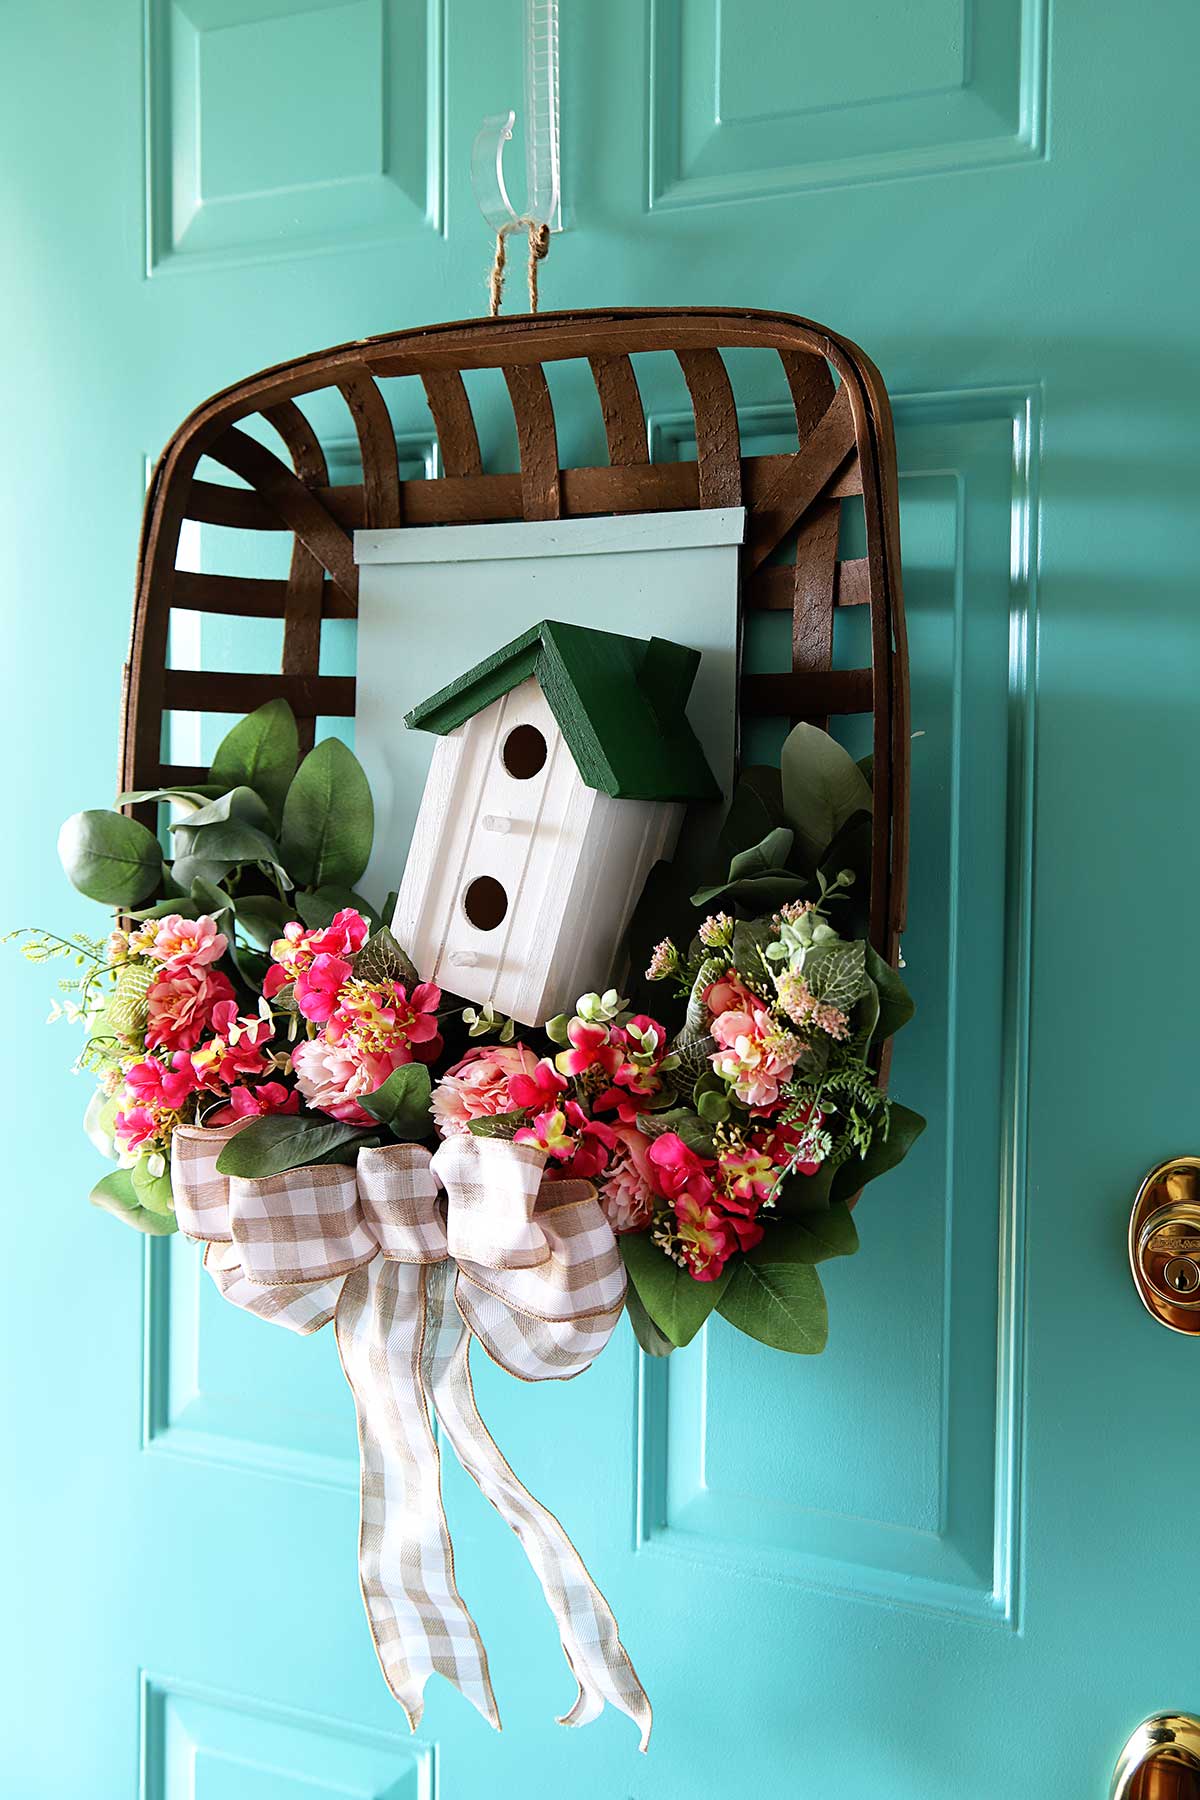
left=171, top=1127, right=651, bottom=1750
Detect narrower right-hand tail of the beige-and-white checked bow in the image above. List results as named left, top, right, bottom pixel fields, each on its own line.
left=423, top=1264, right=651, bottom=1750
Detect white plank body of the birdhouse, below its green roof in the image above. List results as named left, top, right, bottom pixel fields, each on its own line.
left=392, top=675, right=684, bottom=1026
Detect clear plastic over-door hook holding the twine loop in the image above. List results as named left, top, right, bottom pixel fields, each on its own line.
left=471, top=0, right=563, bottom=232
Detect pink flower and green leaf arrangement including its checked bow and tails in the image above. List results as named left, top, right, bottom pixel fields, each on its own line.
left=14, top=700, right=923, bottom=1748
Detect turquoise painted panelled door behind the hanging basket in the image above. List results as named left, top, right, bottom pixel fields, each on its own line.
left=0, top=0, right=1200, bottom=1800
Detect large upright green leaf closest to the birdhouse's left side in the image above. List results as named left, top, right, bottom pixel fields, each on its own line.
left=281, top=738, right=374, bottom=887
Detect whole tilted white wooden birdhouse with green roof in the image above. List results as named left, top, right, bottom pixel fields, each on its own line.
left=392, top=621, right=720, bottom=1024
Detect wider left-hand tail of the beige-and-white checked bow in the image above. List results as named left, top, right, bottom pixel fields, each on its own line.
left=335, top=1256, right=500, bottom=1732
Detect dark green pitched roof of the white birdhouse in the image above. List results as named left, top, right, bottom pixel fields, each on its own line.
left=405, top=619, right=721, bottom=799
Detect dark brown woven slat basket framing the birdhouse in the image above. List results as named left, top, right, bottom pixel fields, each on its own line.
left=121, top=308, right=909, bottom=954
